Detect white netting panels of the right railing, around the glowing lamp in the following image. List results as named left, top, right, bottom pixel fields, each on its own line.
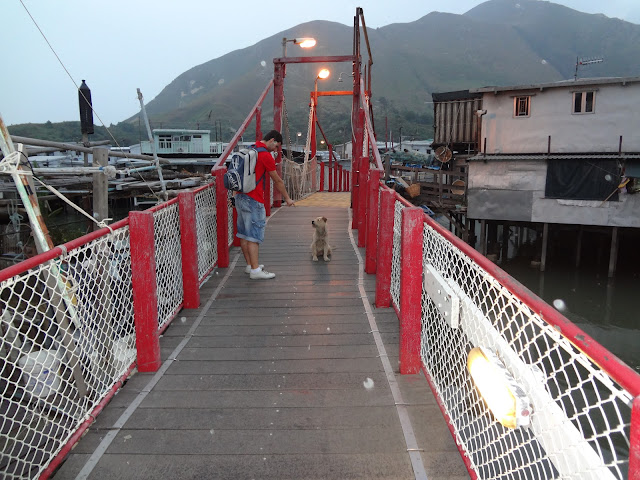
left=384, top=191, right=640, bottom=480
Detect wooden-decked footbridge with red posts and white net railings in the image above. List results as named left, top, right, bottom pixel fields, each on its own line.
left=0, top=186, right=639, bottom=479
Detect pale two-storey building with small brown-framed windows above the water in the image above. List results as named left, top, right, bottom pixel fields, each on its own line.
left=467, top=77, right=640, bottom=228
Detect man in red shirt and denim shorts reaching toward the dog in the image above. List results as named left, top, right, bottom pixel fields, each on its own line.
left=235, top=130, right=295, bottom=280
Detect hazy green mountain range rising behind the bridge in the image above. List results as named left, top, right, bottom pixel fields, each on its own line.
left=10, top=0, right=640, bottom=143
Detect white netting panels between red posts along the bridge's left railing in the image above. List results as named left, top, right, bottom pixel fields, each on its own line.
left=0, top=185, right=222, bottom=479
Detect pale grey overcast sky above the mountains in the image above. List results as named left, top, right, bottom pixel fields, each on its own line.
left=0, top=0, right=640, bottom=126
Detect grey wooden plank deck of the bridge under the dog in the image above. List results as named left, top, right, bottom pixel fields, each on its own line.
left=53, top=194, right=469, bottom=480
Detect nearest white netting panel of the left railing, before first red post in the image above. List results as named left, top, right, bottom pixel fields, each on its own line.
left=0, top=224, right=136, bottom=479
